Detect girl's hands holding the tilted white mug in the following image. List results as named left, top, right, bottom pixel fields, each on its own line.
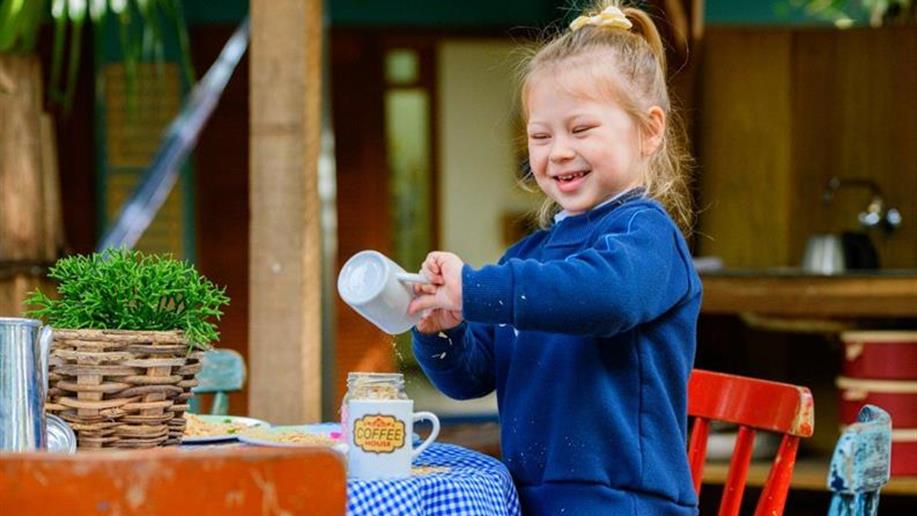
left=408, top=251, right=465, bottom=314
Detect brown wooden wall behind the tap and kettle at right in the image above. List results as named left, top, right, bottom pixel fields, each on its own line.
left=697, top=27, right=917, bottom=268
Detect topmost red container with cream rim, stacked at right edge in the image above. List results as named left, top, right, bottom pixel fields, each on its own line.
left=841, top=331, right=917, bottom=378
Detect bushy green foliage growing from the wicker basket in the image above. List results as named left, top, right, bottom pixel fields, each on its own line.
left=26, top=250, right=229, bottom=349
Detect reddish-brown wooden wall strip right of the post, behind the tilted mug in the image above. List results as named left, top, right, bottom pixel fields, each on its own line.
left=326, top=29, right=395, bottom=404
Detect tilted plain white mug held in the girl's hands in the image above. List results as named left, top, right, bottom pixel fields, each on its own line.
left=338, top=251, right=429, bottom=335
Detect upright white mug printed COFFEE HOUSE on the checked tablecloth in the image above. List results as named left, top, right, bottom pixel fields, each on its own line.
left=345, top=400, right=439, bottom=480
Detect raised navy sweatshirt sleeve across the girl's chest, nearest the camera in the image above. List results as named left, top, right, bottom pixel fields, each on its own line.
left=462, top=208, right=700, bottom=336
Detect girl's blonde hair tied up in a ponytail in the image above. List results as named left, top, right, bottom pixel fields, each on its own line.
left=520, top=0, right=693, bottom=234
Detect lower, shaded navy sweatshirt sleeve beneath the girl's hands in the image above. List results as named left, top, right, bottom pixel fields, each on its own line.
left=412, top=322, right=496, bottom=400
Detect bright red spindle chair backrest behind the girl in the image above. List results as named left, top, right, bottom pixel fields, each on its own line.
left=688, top=369, right=815, bottom=516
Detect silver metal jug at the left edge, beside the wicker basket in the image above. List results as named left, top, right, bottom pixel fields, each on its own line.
left=0, top=317, right=53, bottom=451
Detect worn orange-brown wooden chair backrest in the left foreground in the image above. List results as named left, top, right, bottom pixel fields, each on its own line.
left=0, top=446, right=347, bottom=515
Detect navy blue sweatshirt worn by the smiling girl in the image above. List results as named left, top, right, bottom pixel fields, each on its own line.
left=413, top=194, right=701, bottom=516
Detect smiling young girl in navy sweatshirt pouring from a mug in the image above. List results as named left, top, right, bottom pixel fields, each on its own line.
left=410, top=1, right=701, bottom=515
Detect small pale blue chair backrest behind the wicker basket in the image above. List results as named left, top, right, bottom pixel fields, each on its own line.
left=190, top=349, right=245, bottom=416
